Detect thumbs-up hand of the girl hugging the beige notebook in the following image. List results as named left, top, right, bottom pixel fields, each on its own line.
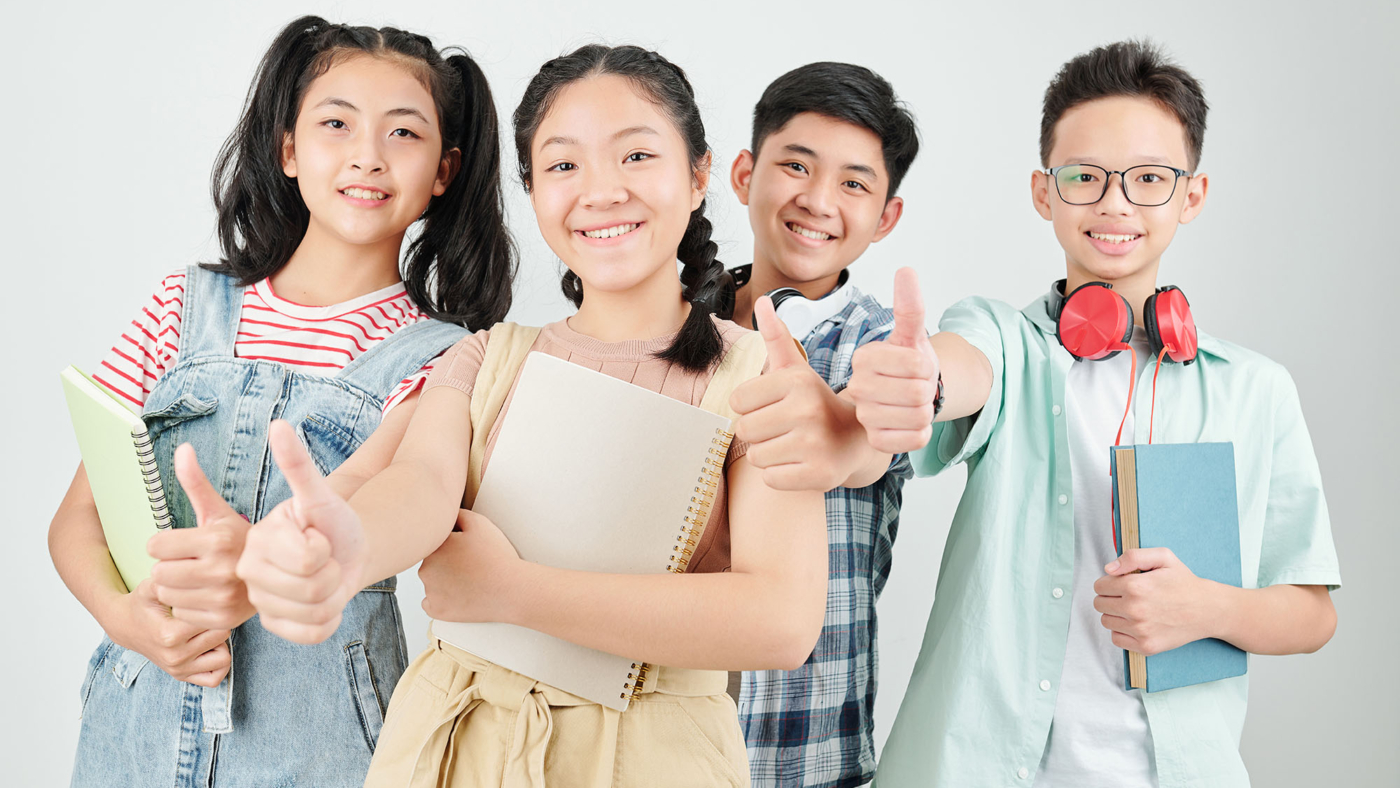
left=238, top=421, right=365, bottom=644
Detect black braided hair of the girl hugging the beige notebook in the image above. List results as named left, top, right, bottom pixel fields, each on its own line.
left=515, top=43, right=734, bottom=371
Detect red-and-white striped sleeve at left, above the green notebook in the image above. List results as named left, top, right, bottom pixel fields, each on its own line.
left=92, top=270, right=185, bottom=411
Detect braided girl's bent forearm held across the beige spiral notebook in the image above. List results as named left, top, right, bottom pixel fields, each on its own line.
left=504, top=563, right=826, bottom=670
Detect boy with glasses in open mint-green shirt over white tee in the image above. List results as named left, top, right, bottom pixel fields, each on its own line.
left=848, top=42, right=1340, bottom=788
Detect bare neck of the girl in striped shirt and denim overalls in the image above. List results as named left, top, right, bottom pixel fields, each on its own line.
left=272, top=218, right=403, bottom=307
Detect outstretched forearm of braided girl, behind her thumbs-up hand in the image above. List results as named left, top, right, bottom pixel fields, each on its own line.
left=350, top=460, right=462, bottom=588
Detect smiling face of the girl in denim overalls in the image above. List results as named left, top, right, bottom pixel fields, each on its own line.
left=281, top=55, right=456, bottom=252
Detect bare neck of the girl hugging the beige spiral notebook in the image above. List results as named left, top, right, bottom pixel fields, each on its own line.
left=568, top=265, right=690, bottom=342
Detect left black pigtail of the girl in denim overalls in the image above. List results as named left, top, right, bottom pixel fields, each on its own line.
left=204, top=17, right=327, bottom=286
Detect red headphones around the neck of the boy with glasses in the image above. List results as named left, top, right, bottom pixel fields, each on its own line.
left=1049, top=279, right=1196, bottom=364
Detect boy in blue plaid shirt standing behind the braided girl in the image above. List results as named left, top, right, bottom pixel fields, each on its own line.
left=731, top=63, right=927, bottom=787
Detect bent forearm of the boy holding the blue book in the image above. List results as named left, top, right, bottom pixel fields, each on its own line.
left=1211, top=584, right=1337, bottom=655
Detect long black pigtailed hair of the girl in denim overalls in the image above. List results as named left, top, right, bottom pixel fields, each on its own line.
left=206, top=17, right=515, bottom=329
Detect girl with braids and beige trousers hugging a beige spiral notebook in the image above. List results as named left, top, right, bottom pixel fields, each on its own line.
left=239, top=46, right=827, bottom=788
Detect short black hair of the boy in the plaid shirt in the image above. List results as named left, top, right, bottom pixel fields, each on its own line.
left=749, top=63, right=918, bottom=200
